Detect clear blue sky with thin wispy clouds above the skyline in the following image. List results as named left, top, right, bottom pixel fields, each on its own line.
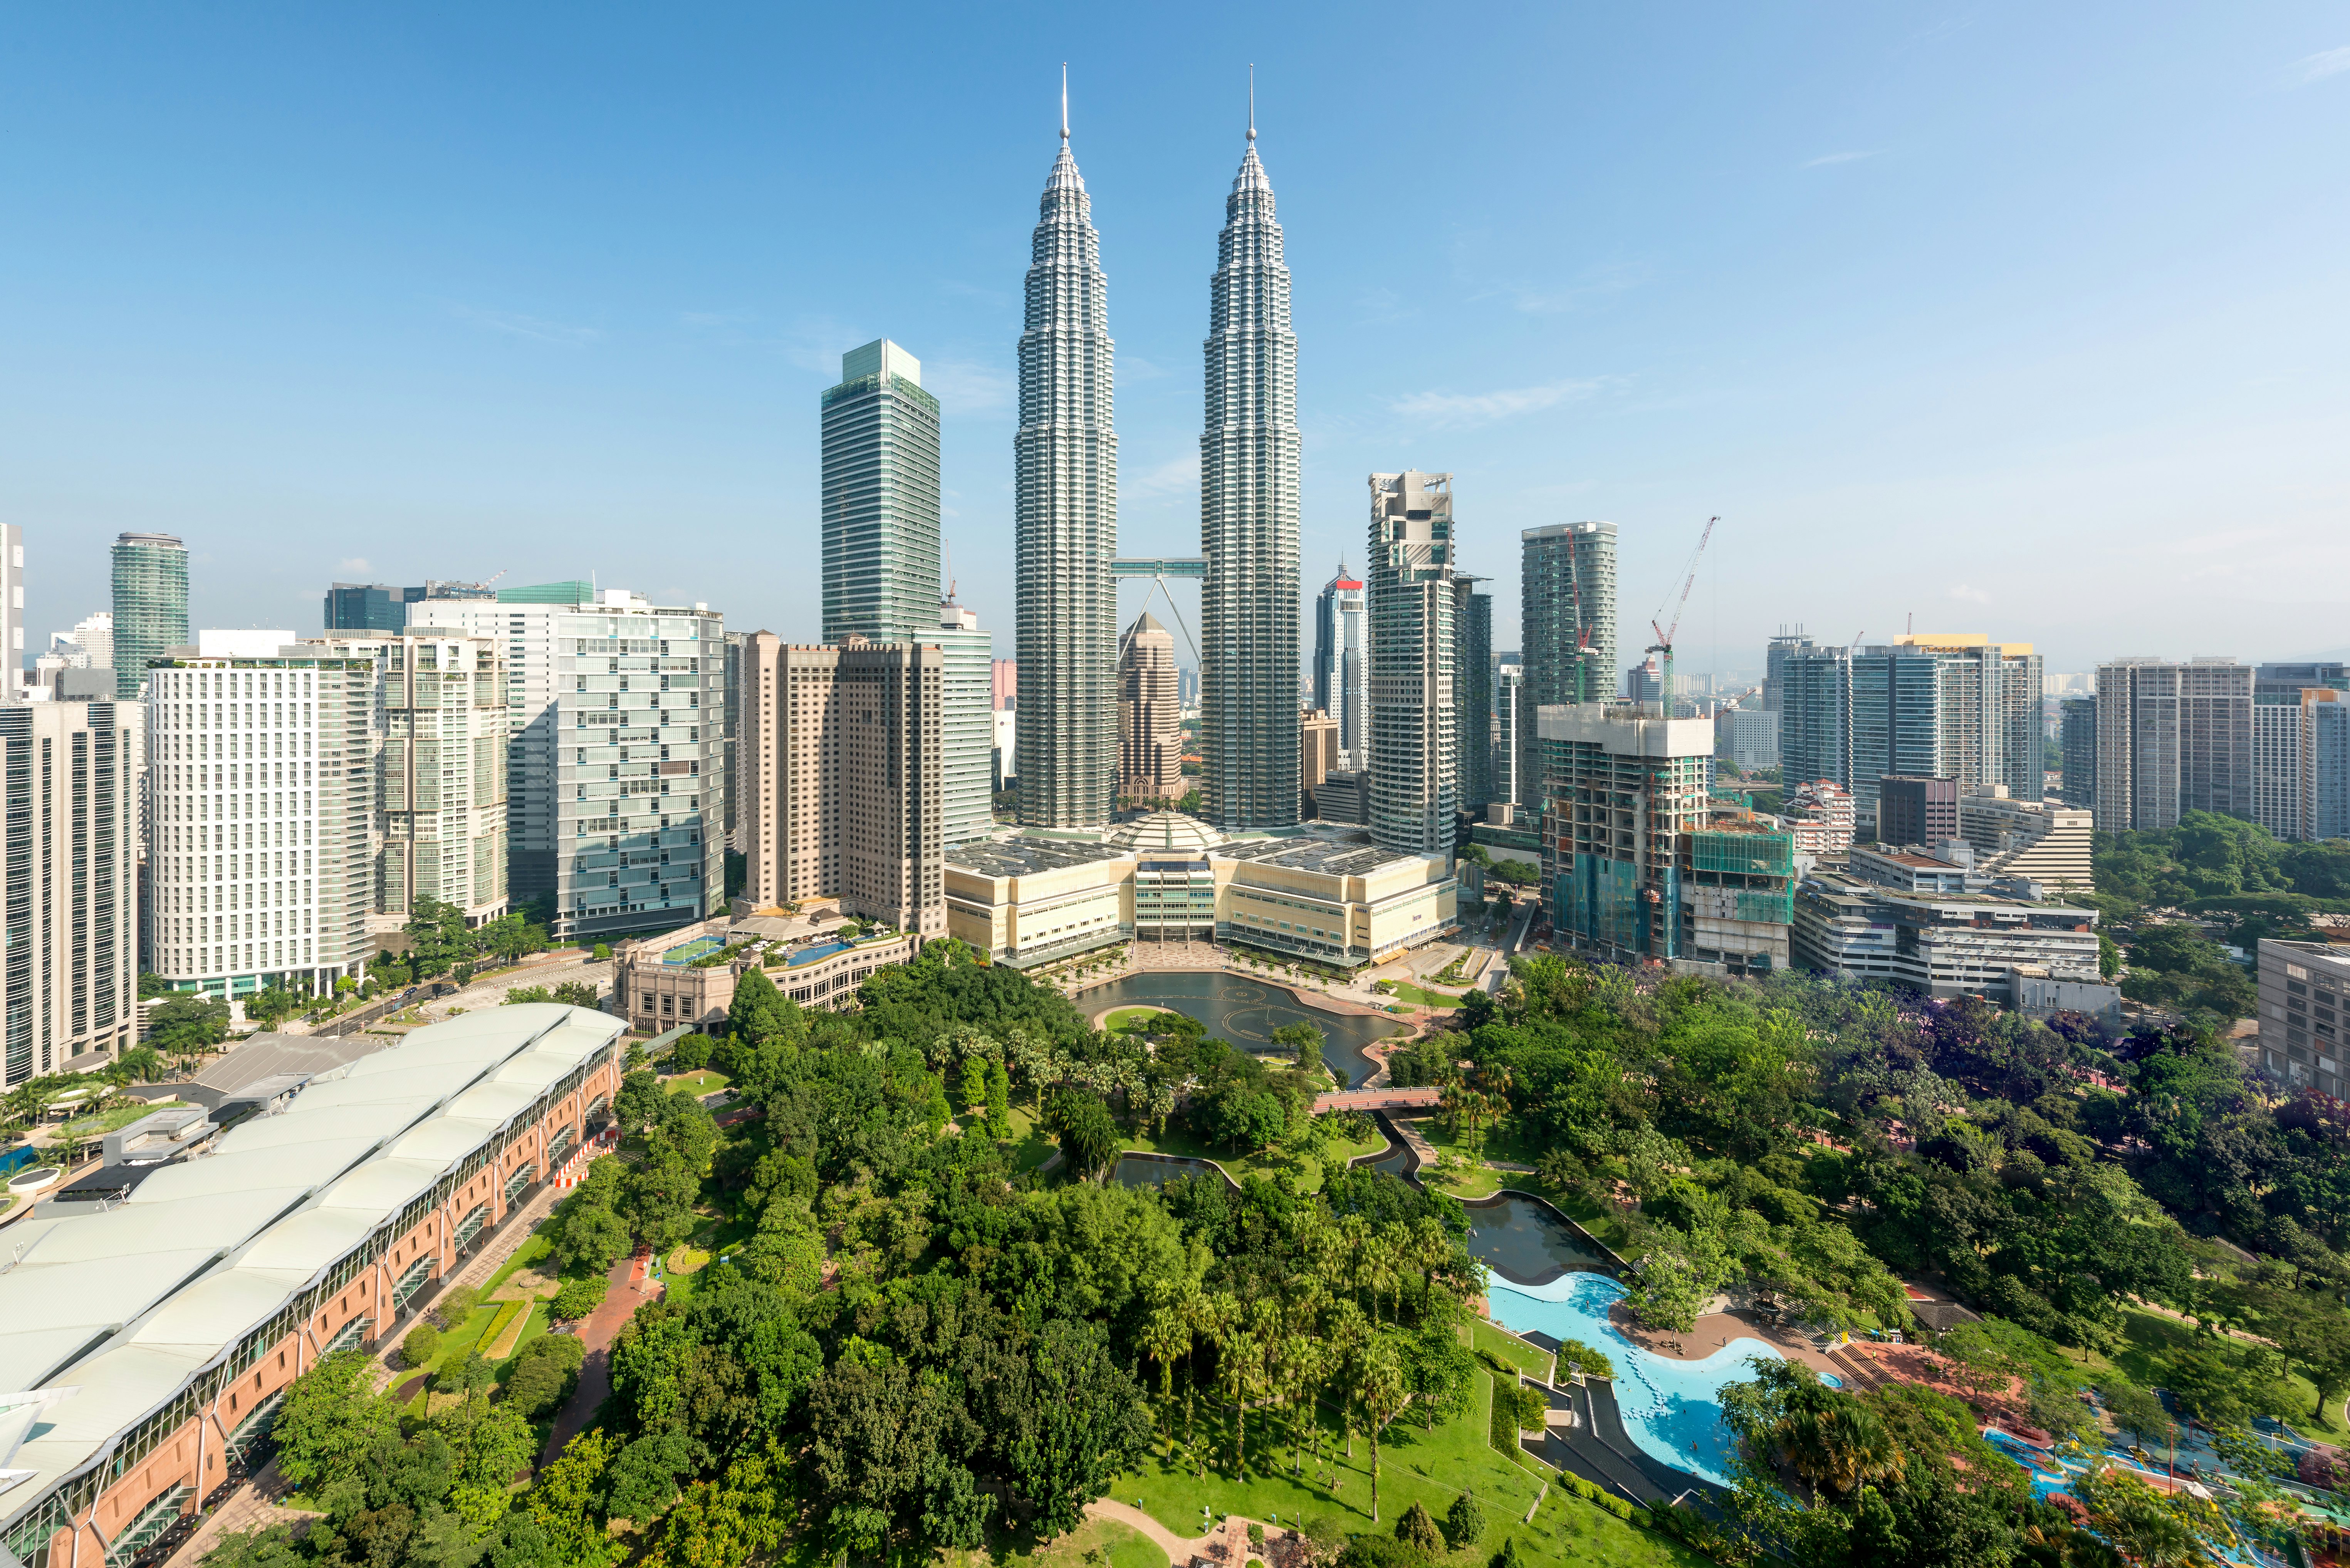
left=0, top=5, right=2350, bottom=670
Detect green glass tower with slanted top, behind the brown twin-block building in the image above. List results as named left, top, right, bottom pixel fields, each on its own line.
left=822, top=339, right=938, bottom=642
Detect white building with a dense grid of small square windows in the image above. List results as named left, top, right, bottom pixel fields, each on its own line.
left=148, top=632, right=376, bottom=997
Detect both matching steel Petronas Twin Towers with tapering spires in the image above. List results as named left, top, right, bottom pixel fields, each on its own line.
left=1013, top=94, right=1297, bottom=830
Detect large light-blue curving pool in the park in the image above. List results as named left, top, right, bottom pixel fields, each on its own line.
left=1485, top=1272, right=1781, bottom=1486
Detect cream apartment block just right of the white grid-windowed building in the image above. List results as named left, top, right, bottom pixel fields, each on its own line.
left=315, top=628, right=508, bottom=931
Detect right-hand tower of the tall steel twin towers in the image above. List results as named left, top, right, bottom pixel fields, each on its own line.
left=1198, top=124, right=1297, bottom=830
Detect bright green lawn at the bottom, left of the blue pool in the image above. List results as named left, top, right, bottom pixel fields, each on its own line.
left=1109, top=1378, right=1704, bottom=1568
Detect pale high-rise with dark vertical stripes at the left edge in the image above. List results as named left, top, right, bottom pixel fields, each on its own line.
left=0, top=701, right=141, bottom=1091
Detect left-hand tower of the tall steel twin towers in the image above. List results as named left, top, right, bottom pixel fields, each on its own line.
left=1013, top=115, right=1118, bottom=827
